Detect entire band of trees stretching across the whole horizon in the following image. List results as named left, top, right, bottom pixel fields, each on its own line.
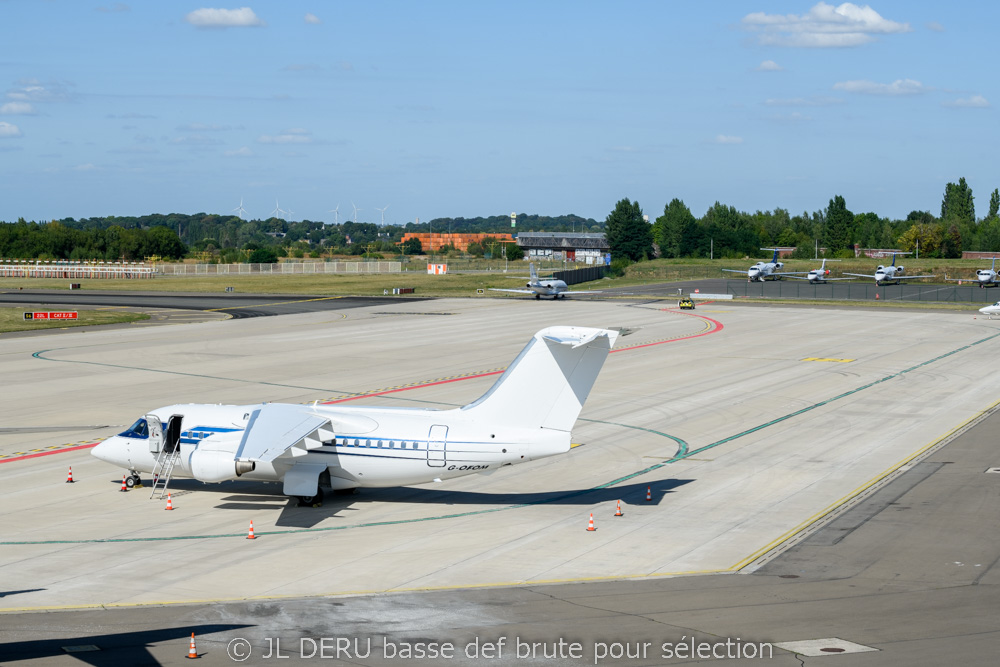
left=0, top=177, right=1000, bottom=262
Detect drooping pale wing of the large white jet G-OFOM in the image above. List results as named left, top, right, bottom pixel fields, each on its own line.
left=236, top=403, right=330, bottom=462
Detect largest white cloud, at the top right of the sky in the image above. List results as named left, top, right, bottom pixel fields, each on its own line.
left=742, top=2, right=912, bottom=48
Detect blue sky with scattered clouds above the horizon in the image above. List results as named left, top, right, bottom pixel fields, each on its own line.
left=0, top=0, right=1000, bottom=223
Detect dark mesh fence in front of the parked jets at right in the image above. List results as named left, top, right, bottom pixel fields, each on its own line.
left=726, top=280, right=1000, bottom=304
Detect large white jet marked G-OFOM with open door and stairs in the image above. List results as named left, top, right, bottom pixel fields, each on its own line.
left=93, top=326, right=618, bottom=505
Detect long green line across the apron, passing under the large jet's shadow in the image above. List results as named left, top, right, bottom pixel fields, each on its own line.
left=0, top=333, right=1000, bottom=546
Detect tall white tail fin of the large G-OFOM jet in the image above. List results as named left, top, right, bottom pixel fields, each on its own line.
left=462, top=326, right=618, bottom=432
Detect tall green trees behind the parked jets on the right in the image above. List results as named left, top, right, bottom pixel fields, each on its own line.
left=605, top=177, right=1000, bottom=262
